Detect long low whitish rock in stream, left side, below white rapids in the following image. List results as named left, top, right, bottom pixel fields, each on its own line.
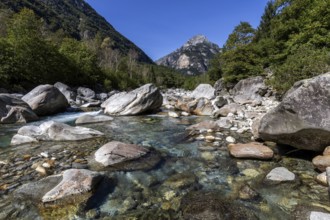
left=11, top=121, right=104, bottom=145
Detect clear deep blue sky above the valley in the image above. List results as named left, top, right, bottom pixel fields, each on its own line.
left=86, top=0, right=268, bottom=60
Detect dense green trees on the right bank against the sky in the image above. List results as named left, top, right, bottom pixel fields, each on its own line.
left=209, top=0, right=330, bottom=93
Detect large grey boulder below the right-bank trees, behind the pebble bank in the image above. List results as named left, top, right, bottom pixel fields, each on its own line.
left=232, top=76, right=268, bottom=104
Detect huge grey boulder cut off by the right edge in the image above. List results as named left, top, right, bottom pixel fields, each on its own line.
left=259, top=73, right=330, bottom=151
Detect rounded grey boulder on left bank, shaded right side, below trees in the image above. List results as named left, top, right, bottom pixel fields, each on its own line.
left=22, top=85, right=69, bottom=116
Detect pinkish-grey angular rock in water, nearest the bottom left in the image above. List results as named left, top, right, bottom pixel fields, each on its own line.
left=42, top=169, right=102, bottom=202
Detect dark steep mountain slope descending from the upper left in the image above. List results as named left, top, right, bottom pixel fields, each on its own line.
left=0, top=0, right=152, bottom=63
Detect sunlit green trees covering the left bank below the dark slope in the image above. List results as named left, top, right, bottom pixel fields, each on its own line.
left=0, top=8, right=183, bottom=92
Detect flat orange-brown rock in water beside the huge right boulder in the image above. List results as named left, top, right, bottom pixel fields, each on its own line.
left=228, top=142, right=274, bottom=159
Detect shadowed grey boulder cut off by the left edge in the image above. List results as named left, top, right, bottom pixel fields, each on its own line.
left=0, top=94, right=39, bottom=124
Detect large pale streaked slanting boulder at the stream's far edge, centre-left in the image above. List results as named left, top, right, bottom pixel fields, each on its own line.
left=101, top=84, right=163, bottom=115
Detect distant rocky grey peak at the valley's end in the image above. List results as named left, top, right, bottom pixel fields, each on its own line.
left=156, top=35, right=220, bottom=75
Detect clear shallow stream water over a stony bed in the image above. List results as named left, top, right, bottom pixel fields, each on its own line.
left=0, top=113, right=330, bottom=219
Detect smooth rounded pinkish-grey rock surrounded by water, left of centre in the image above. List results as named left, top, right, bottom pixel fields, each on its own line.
left=94, top=141, right=149, bottom=167
